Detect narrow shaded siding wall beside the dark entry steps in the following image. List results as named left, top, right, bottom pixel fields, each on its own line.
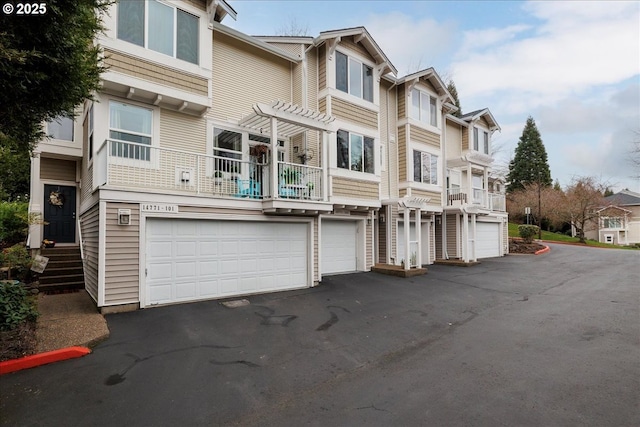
left=80, top=204, right=100, bottom=301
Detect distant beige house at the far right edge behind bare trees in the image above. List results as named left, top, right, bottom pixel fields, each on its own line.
left=585, top=190, right=640, bottom=245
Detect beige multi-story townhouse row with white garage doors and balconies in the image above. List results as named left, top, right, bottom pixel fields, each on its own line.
left=30, top=0, right=507, bottom=311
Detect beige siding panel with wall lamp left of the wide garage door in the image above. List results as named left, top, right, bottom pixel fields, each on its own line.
left=104, top=202, right=140, bottom=305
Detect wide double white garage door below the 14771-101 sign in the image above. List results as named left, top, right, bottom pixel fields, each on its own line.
left=146, top=218, right=309, bottom=305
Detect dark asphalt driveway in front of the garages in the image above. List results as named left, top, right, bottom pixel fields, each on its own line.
left=0, top=245, right=640, bottom=426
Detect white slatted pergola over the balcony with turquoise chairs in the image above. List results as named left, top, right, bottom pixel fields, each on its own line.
left=239, top=101, right=336, bottom=137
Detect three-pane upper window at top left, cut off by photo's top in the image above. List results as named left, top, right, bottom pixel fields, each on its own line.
left=117, top=0, right=198, bottom=64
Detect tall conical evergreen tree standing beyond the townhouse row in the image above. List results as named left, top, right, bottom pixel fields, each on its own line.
left=507, top=116, right=552, bottom=193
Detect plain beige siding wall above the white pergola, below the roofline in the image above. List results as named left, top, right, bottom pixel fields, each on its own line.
left=208, top=32, right=291, bottom=120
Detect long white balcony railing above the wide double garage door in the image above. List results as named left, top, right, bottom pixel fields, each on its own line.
left=94, top=139, right=323, bottom=200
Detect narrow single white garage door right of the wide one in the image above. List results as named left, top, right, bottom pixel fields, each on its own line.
left=320, top=220, right=358, bottom=274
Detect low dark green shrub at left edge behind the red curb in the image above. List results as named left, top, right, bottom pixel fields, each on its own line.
left=0, top=282, right=38, bottom=331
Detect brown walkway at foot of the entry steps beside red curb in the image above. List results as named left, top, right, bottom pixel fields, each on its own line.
left=36, top=291, right=109, bottom=353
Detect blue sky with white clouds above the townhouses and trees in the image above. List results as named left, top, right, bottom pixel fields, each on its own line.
left=224, top=0, right=640, bottom=192
